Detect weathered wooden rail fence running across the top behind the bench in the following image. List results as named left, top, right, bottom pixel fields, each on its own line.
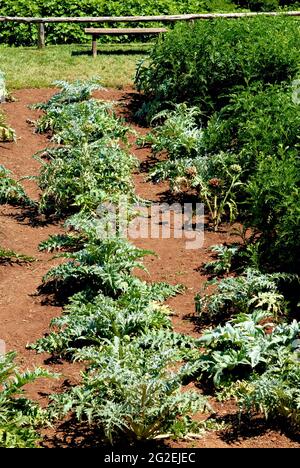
left=0, top=11, right=300, bottom=48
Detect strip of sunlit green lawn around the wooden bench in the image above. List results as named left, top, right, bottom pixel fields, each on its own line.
left=0, top=43, right=151, bottom=90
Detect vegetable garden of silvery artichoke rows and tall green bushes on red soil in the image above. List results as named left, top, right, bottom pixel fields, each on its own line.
left=0, top=11, right=300, bottom=447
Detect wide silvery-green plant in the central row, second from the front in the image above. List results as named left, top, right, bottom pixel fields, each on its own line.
left=31, top=282, right=178, bottom=356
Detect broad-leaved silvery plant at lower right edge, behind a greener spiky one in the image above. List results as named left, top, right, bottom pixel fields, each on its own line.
left=192, top=310, right=300, bottom=387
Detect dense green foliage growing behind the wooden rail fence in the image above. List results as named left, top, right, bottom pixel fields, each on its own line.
left=0, top=0, right=238, bottom=46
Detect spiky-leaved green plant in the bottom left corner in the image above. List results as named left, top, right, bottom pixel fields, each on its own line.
left=0, top=353, right=51, bottom=448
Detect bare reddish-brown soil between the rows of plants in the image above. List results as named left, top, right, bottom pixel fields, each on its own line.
left=0, top=89, right=300, bottom=448
